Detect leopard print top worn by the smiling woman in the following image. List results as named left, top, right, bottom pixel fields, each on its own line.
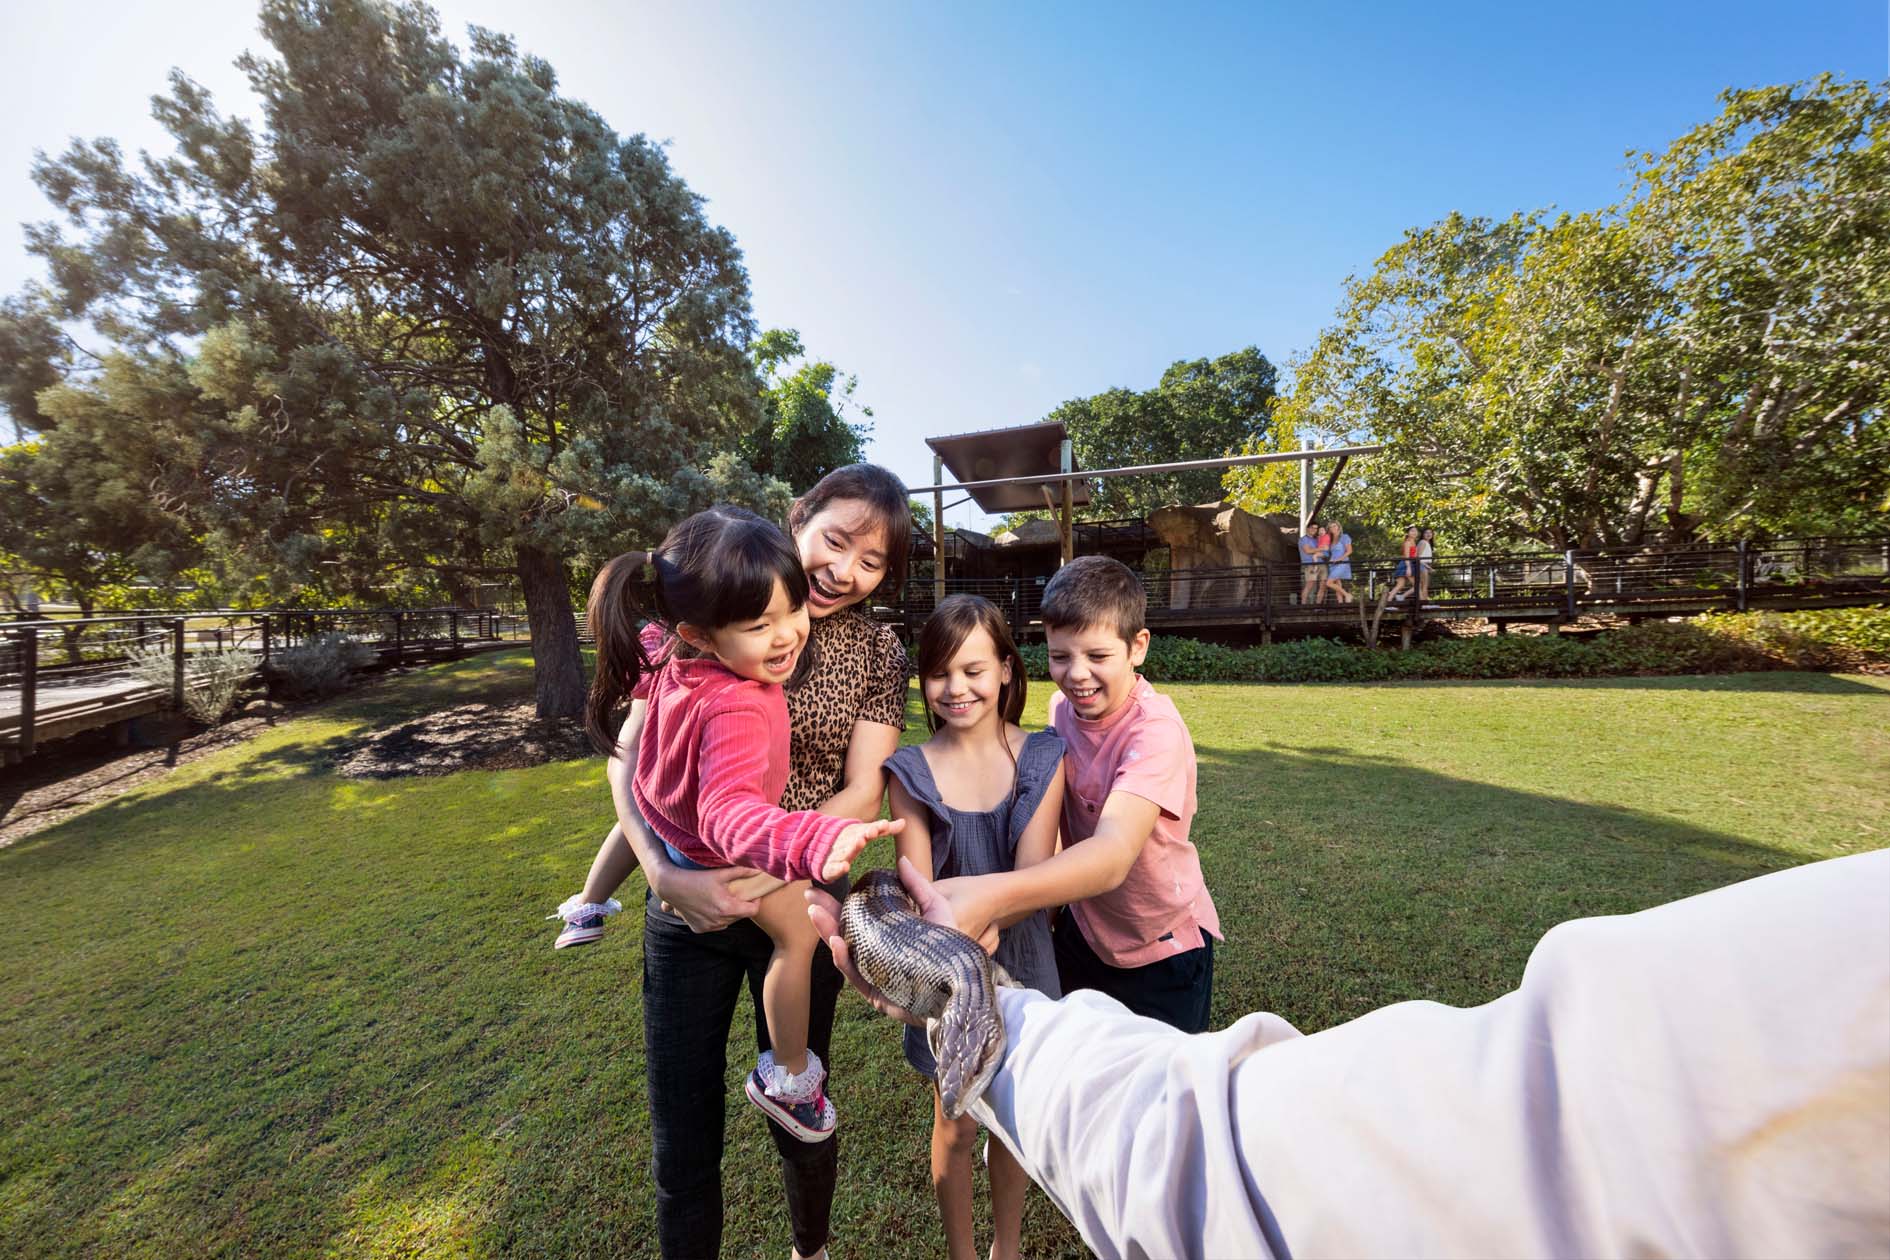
left=781, top=608, right=909, bottom=809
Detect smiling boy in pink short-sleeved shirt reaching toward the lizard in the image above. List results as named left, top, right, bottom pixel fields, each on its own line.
left=918, top=555, right=1221, bottom=1033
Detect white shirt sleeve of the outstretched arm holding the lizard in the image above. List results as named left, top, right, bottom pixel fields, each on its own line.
left=973, top=852, right=1890, bottom=1260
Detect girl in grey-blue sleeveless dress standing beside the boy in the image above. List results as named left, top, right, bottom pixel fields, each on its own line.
left=886, top=595, right=1064, bottom=1260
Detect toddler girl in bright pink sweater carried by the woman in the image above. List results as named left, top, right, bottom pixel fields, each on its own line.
left=584, top=506, right=903, bottom=1141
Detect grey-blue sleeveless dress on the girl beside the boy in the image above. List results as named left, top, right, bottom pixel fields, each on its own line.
left=886, top=731, right=1064, bottom=1077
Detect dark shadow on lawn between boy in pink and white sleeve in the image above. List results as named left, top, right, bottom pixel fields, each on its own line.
left=1194, top=746, right=1848, bottom=1030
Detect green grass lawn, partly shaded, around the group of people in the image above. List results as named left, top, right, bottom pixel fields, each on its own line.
left=0, top=654, right=1890, bottom=1258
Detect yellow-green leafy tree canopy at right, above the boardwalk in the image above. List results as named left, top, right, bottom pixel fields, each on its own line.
left=1229, top=77, right=1890, bottom=548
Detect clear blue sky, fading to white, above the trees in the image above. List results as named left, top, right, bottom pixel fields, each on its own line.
left=0, top=0, right=1890, bottom=525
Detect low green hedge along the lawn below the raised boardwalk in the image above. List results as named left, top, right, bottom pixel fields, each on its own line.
left=1022, top=608, right=1890, bottom=682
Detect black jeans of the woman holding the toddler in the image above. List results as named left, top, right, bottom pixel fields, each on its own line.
left=643, top=897, right=841, bottom=1260
